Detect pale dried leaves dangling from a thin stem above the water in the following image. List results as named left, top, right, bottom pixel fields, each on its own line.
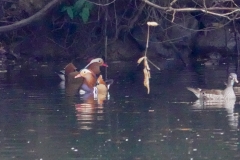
left=137, top=56, right=151, bottom=94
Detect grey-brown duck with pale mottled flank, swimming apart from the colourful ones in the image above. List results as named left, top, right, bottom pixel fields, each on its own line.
left=187, top=73, right=238, bottom=100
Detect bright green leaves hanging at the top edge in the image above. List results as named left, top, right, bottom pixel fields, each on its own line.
left=61, top=0, right=93, bottom=23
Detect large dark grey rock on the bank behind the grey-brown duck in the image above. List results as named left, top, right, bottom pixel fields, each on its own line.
left=194, top=15, right=236, bottom=56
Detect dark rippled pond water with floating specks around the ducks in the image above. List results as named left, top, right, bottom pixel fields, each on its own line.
left=0, top=62, right=240, bottom=160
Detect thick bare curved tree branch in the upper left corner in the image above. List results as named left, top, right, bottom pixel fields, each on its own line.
left=0, top=0, right=62, bottom=33
